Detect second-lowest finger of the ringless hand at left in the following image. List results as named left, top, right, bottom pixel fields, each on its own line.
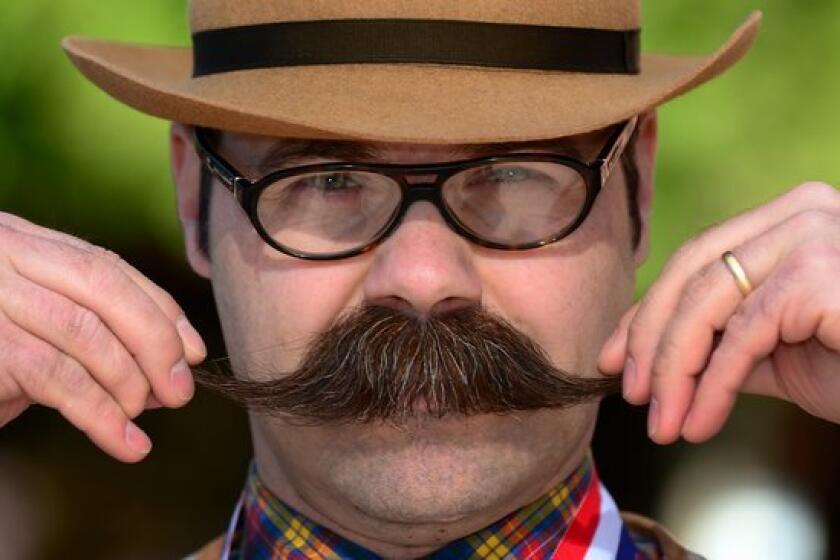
left=0, top=275, right=150, bottom=418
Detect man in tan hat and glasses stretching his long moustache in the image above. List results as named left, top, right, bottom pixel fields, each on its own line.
left=0, top=0, right=840, bottom=558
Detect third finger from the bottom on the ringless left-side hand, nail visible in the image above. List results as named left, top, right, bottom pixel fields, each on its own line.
left=3, top=228, right=194, bottom=407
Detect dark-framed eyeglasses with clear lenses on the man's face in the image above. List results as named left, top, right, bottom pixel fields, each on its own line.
left=195, top=117, right=638, bottom=260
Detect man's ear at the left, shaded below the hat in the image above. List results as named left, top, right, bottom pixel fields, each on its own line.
left=169, top=123, right=210, bottom=279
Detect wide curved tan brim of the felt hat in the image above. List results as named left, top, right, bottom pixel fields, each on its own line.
left=63, top=12, right=761, bottom=144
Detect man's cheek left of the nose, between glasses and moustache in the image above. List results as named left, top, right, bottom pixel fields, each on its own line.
left=211, top=187, right=365, bottom=379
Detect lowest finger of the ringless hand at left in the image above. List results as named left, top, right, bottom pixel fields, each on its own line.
left=0, top=314, right=151, bottom=463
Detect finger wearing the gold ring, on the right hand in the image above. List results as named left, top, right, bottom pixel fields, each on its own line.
left=634, top=211, right=840, bottom=443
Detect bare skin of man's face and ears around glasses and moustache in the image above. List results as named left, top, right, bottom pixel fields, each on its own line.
left=173, top=115, right=655, bottom=546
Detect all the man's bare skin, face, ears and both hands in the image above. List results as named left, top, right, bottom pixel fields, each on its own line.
left=0, top=108, right=840, bottom=558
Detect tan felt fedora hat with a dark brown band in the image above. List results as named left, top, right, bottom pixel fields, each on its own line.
left=63, top=0, right=761, bottom=143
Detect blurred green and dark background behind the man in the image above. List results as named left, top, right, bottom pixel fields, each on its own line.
left=0, top=0, right=840, bottom=559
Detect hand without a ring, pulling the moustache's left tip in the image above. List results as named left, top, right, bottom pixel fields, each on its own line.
left=0, top=213, right=206, bottom=462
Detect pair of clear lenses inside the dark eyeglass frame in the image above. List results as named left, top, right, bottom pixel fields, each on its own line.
left=257, top=161, right=587, bottom=255
